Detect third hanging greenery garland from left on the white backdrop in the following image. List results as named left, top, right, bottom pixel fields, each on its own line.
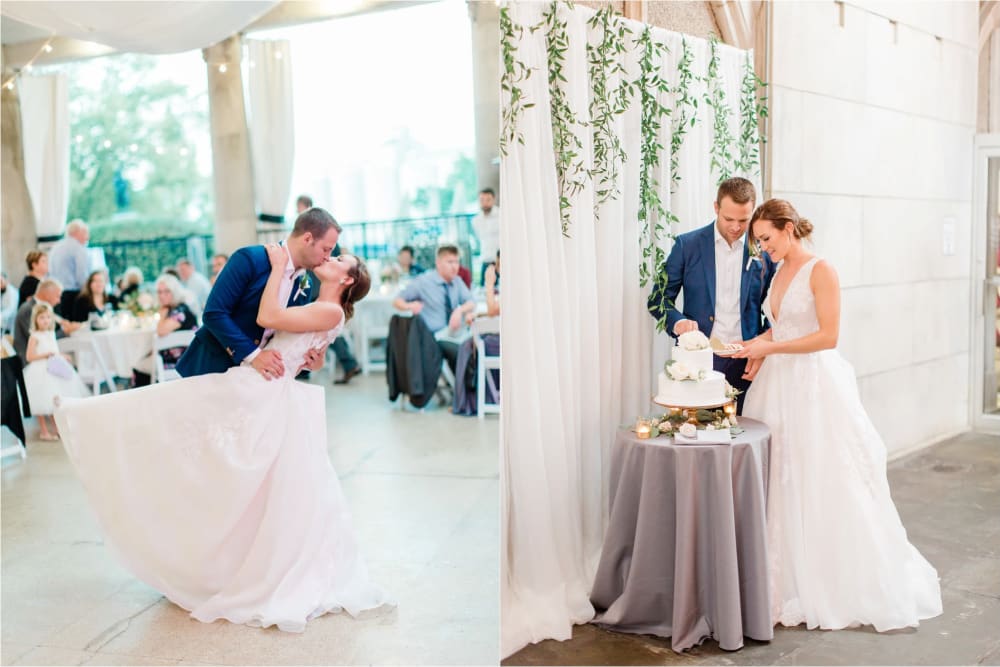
left=587, top=5, right=633, bottom=219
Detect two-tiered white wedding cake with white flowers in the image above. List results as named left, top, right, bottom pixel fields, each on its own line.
left=653, top=331, right=729, bottom=408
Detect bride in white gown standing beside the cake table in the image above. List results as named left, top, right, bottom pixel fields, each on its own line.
left=737, top=199, right=941, bottom=631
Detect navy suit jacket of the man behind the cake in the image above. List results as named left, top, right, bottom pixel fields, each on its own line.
left=646, top=221, right=774, bottom=343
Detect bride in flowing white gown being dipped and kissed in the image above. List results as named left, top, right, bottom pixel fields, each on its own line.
left=55, top=246, right=388, bottom=632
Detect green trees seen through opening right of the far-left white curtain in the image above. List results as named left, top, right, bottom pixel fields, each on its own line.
left=69, top=54, right=212, bottom=239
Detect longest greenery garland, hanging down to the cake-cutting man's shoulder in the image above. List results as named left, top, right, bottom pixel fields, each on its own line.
left=636, top=26, right=676, bottom=287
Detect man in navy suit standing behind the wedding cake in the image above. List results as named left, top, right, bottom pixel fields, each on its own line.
left=647, top=178, right=774, bottom=414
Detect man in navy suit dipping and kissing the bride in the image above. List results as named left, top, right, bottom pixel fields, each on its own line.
left=176, top=208, right=341, bottom=380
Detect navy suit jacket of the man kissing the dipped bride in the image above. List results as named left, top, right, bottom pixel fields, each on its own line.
left=176, top=245, right=315, bottom=377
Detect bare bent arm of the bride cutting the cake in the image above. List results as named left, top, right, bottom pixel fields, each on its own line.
left=733, top=260, right=840, bottom=359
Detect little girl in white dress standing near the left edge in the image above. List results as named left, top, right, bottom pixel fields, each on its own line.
left=24, top=302, right=90, bottom=440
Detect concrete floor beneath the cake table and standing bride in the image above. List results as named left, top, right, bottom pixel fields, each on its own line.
left=503, top=434, right=1000, bottom=665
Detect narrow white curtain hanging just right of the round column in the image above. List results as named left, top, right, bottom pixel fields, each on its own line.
left=246, top=39, right=295, bottom=222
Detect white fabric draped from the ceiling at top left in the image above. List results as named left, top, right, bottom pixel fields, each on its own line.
left=0, top=0, right=278, bottom=53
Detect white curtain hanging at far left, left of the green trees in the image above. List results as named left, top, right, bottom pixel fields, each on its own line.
left=18, top=73, right=69, bottom=236
